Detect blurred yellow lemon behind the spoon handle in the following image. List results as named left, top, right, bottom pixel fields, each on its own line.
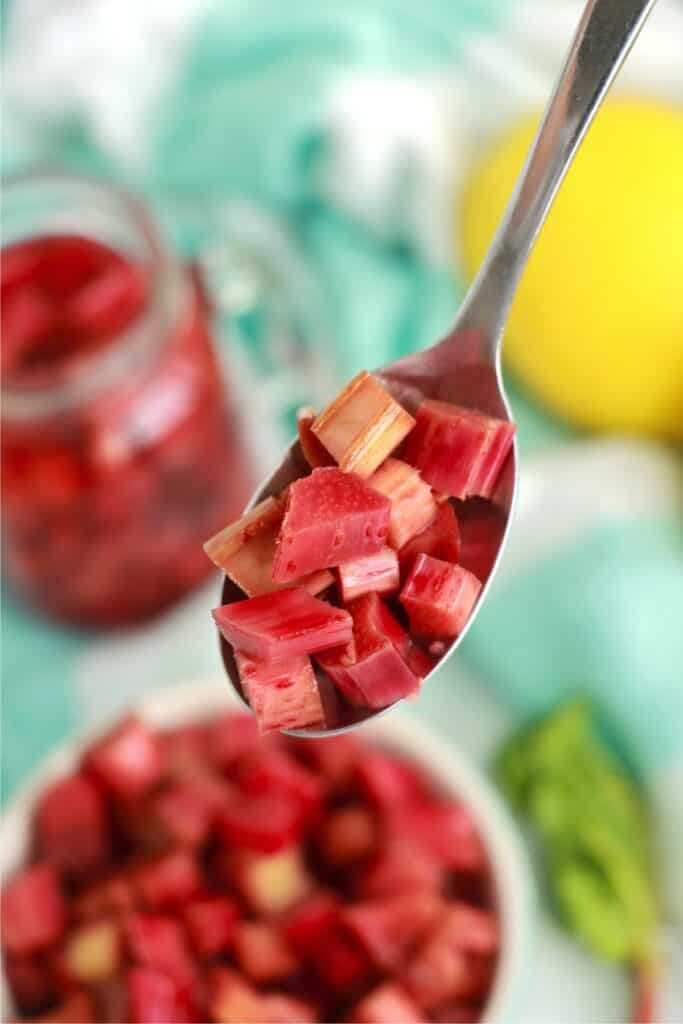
left=461, top=99, right=683, bottom=439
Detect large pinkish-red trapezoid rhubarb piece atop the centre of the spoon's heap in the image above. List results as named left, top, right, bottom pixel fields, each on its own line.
left=272, top=467, right=391, bottom=583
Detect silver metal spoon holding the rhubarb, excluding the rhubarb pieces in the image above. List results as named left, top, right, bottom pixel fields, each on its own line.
left=221, top=0, right=654, bottom=738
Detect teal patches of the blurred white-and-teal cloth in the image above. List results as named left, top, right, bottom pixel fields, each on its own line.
left=2, top=0, right=683, bottom=793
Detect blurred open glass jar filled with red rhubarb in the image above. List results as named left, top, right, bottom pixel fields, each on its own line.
left=0, top=174, right=250, bottom=627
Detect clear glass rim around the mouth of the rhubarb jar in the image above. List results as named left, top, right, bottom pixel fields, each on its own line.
left=0, top=167, right=182, bottom=421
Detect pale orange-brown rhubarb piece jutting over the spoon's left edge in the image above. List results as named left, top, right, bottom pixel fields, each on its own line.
left=204, top=498, right=334, bottom=597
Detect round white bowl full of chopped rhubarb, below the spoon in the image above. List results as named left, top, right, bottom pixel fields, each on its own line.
left=1, top=681, right=529, bottom=1024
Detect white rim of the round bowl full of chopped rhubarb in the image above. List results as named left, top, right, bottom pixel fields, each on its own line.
left=0, top=680, right=533, bottom=1022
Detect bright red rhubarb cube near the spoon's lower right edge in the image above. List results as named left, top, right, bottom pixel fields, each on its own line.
left=399, top=555, right=481, bottom=640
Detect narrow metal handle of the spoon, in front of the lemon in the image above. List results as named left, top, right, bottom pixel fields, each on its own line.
left=456, top=0, right=654, bottom=361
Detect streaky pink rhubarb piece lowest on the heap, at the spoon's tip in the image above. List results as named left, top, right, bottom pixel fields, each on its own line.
left=234, top=650, right=325, bottom=734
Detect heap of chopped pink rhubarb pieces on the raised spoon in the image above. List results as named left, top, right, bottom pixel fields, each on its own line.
left=205, top=372, right=515, bottom=733
